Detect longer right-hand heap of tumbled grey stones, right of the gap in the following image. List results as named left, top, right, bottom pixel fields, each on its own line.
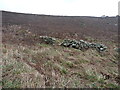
left=61, top=39, right=107, bottom=52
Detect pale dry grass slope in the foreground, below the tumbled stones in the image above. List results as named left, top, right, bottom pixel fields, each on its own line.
left=2, top=40, right=118, bottom=88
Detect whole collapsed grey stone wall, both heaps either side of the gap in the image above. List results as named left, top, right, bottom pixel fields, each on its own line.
left=40, top=36, right=107, bottom=52
